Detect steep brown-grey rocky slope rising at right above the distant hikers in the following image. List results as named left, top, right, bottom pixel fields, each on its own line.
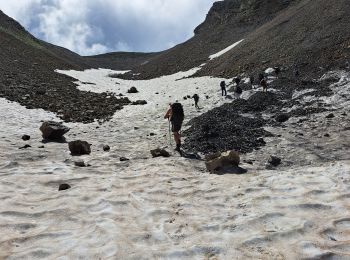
left=118, top=0, right=350, bottom=78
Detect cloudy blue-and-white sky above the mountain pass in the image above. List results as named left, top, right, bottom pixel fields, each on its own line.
left=0, top=0, right=215, bottom=55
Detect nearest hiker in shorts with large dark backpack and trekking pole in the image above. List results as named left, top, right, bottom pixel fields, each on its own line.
left=164, top=101, right=185, bottom=153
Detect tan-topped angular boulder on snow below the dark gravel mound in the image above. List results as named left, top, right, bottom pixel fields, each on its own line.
left=205, top=150, right=240, bottom=173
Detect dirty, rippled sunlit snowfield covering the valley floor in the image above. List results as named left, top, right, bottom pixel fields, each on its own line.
left=0, top=69, right=350, bottom=259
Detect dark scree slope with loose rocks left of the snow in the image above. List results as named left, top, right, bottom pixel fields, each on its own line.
left=0, top=11, right=153, bottom=122
